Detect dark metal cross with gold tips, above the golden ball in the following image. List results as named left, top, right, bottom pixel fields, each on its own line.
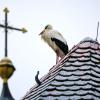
left=0, top=8, right=27, bottom=57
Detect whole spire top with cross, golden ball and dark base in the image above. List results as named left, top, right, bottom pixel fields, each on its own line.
left=0, top=8, right=27, bottom=100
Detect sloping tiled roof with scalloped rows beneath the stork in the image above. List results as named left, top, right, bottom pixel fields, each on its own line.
left=22, top=38, right=100, bottom=100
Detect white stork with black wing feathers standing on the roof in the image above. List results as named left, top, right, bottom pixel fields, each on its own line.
left=39, top=25, right=68, bottom=64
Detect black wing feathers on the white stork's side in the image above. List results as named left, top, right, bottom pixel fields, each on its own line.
left=51, top=38, right=68, bottom=55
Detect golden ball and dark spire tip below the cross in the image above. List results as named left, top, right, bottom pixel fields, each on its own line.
left=0, top=57, right=15, bottom=100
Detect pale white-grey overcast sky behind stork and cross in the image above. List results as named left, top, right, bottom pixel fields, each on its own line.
left=0, top=0, right=100, bottom=100
